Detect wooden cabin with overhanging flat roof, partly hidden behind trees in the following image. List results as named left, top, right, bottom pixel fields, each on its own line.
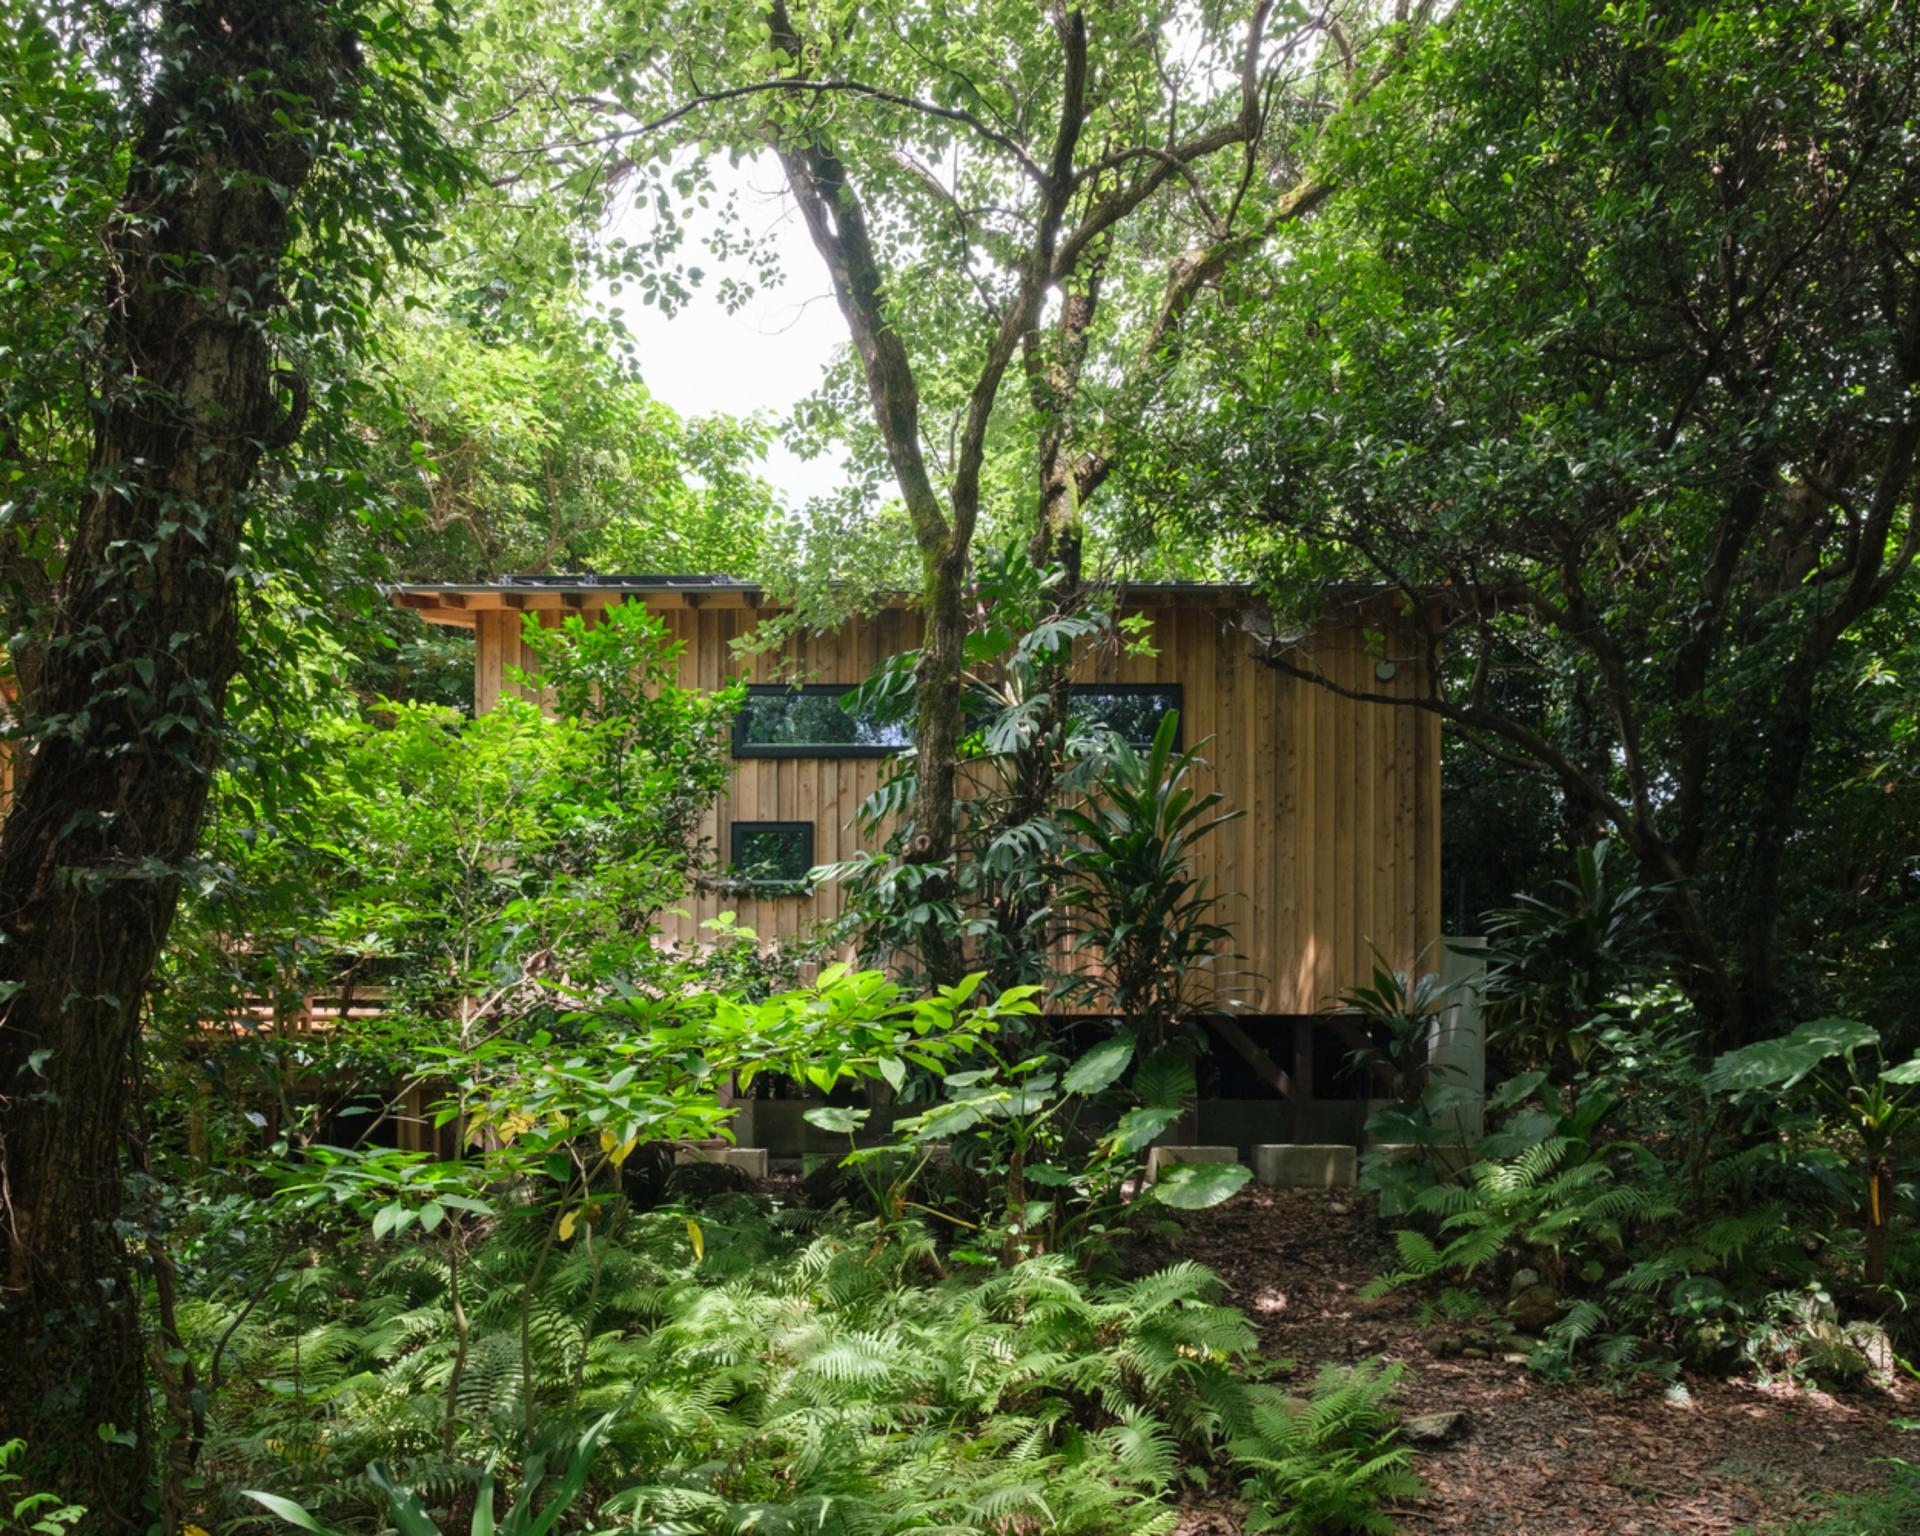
left=396, top=576, right=1440, bottom=1018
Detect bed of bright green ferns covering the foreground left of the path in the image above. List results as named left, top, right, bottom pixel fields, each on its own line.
left=210, top=1196, right=1413, bottom=1536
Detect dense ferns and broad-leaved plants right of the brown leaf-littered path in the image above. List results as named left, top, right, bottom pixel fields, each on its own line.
left=1363, top=849, right=1920, bottom=1384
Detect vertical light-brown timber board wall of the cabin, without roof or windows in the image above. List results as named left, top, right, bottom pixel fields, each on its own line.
left=463, top=595, right=1440, bottom=1014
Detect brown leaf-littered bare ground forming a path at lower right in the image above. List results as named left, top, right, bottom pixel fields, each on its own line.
left=1150, top=1187, right=1916, bottom=1536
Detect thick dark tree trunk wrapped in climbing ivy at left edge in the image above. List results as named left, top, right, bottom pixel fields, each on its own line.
left=0, top=0, right=353, bottom=1530
